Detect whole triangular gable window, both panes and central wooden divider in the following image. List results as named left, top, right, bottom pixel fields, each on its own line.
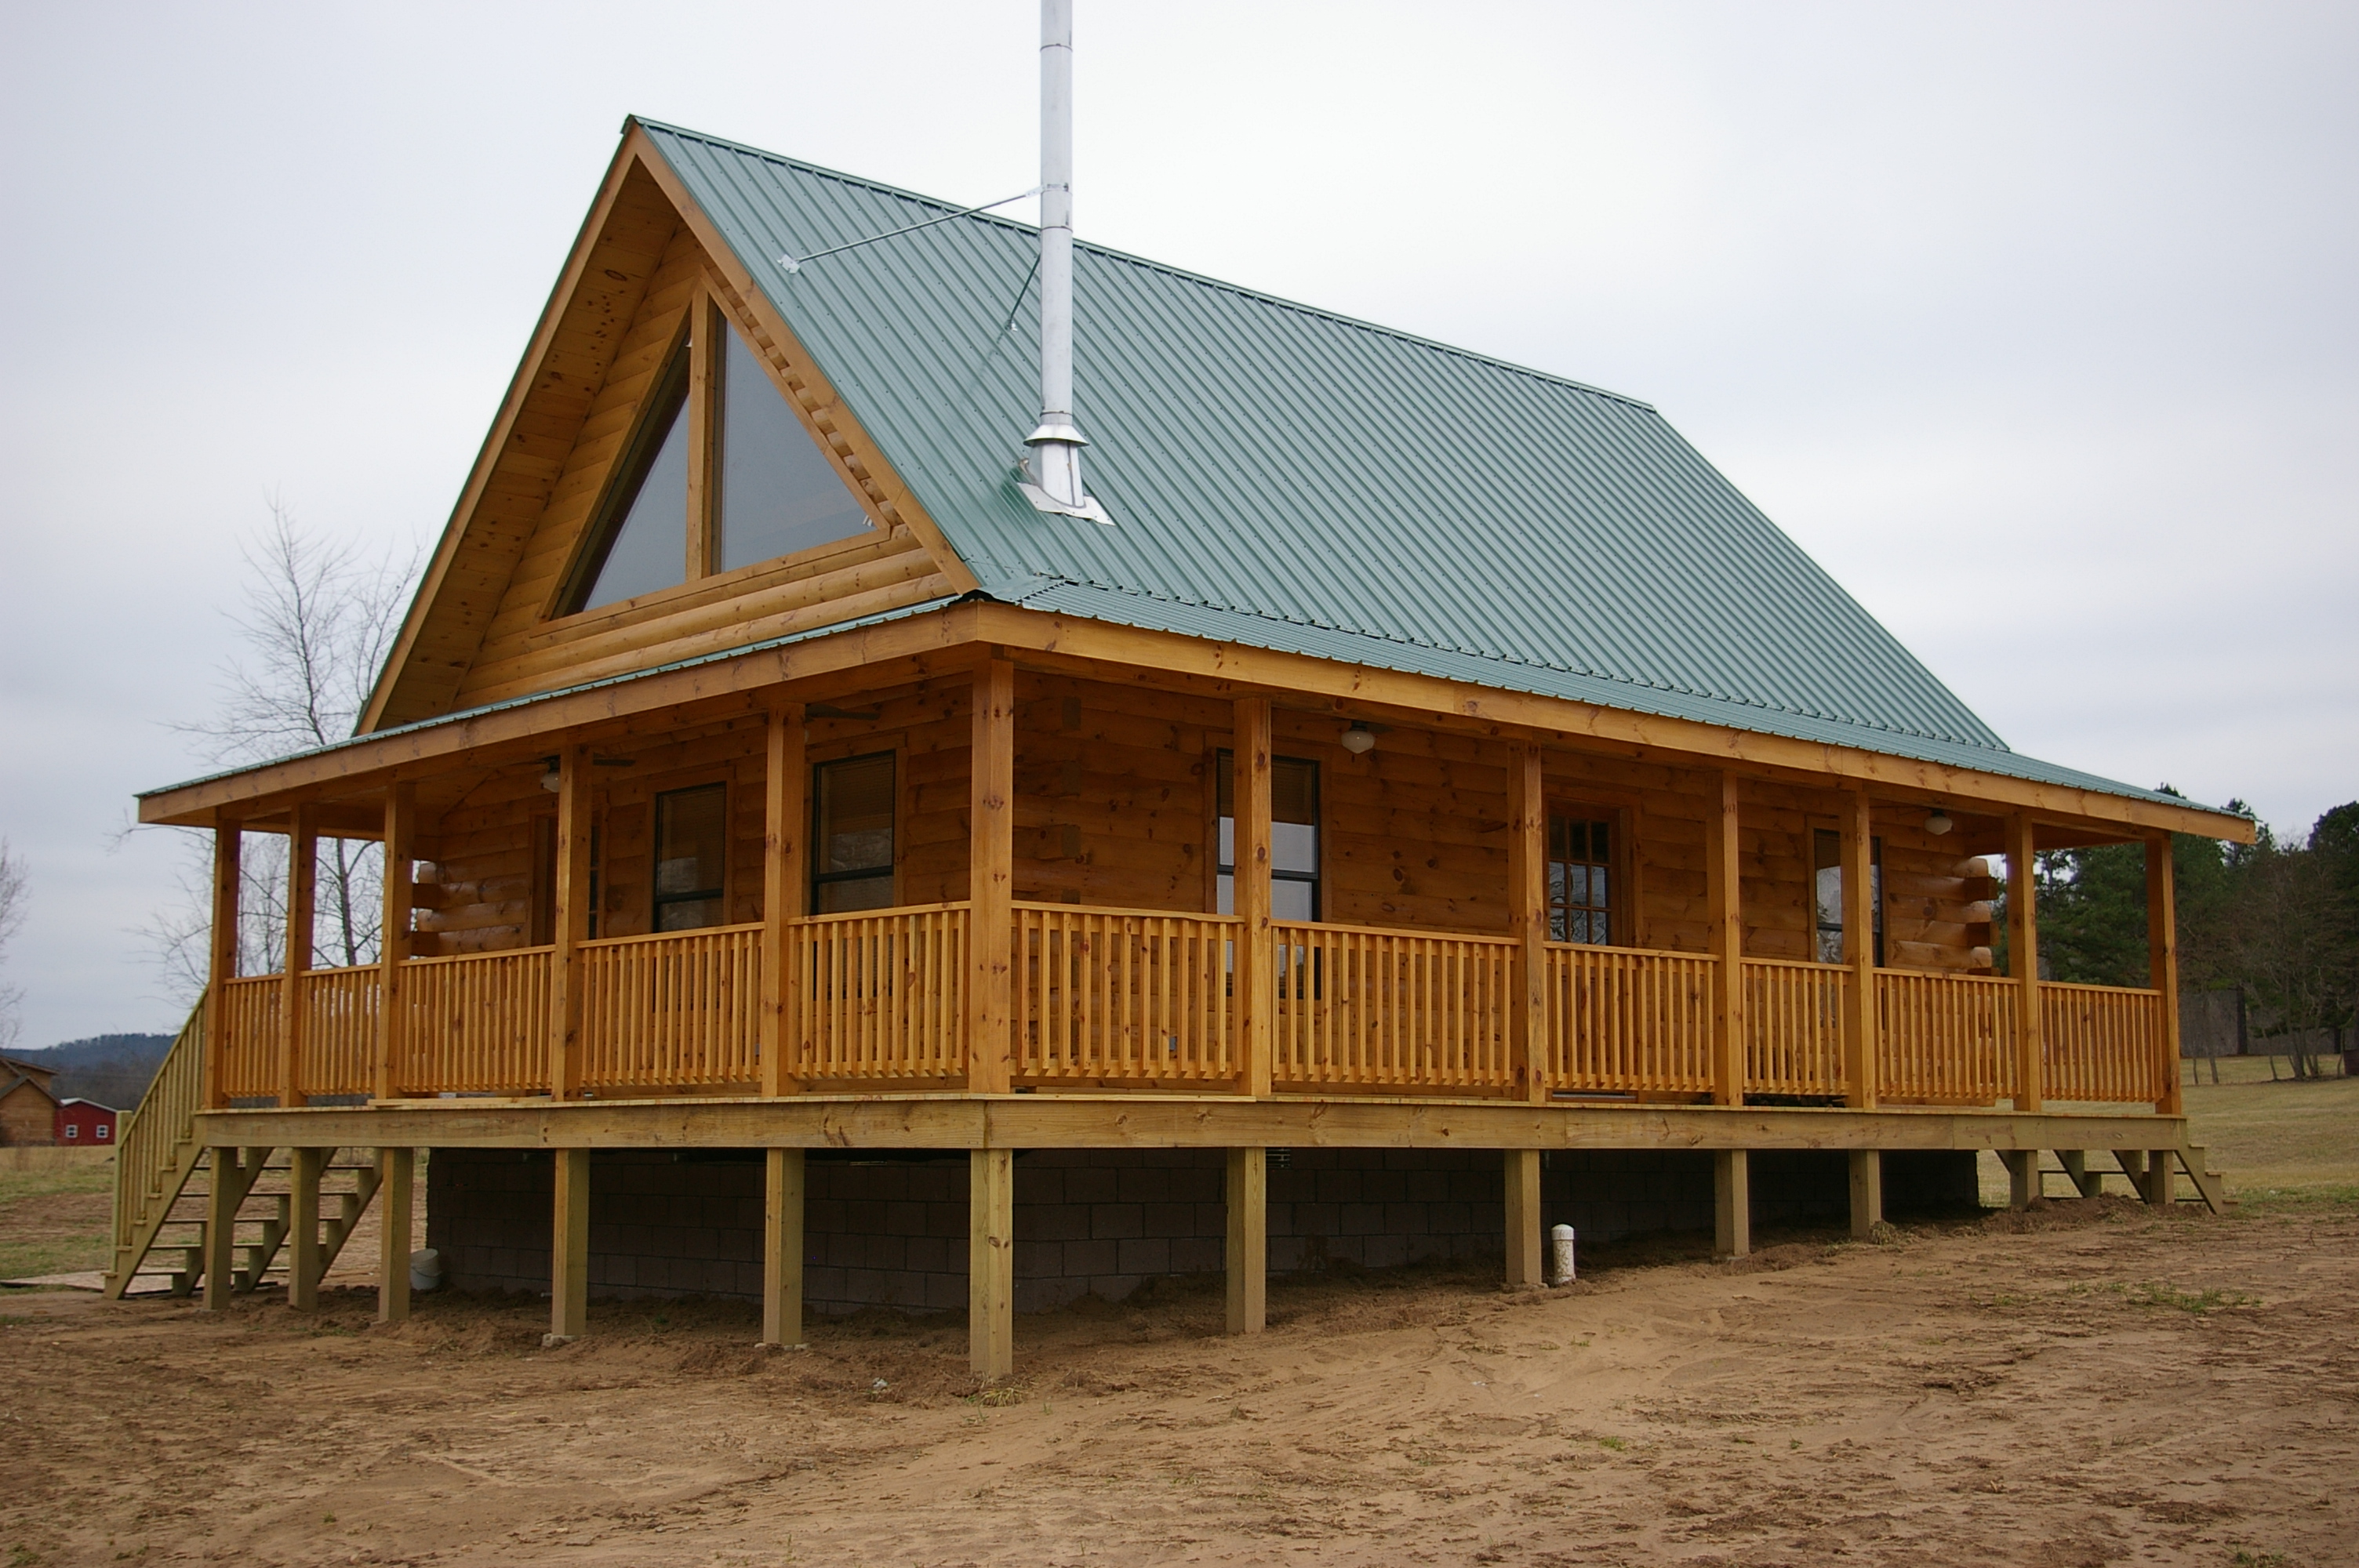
left=562, top=309, right=873, bottom=615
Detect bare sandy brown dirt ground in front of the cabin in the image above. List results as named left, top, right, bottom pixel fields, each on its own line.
left=0, top=1196, right=2359, bottom=1568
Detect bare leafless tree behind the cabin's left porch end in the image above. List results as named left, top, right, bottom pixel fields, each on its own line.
left=146, top=495, right=417, bottom=1000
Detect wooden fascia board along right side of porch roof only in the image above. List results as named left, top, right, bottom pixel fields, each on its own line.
left=976, top=604, right=2255, bottom=844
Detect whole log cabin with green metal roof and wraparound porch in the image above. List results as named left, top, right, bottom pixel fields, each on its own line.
left=108, top=107, right=2253, bottom=1377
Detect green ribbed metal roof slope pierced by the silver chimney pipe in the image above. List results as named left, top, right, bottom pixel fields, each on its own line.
left=639, top=120, right=2184, bottom=804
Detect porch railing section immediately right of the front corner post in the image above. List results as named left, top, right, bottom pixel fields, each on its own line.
left=1014, top=903, right=1243, bottom=1084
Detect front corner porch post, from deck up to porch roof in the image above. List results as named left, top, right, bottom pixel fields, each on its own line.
left=967, top=658, right=1016, bottom=1089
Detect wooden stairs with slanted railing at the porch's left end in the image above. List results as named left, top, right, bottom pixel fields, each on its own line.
left=106, top=1002, right=384, bottom=1301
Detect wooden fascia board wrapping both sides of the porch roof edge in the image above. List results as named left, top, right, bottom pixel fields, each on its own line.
left=139, top=601, right=2253, bottom=844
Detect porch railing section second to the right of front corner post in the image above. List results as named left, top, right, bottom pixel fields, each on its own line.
left=1271, top=922, right=1517, bottom=1091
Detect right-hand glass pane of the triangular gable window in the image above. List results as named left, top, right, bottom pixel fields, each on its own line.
left=714, top=328, right=868, bottom=571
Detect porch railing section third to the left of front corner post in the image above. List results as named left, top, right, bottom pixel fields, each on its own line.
left=394, top=948, right=552, bottom=1094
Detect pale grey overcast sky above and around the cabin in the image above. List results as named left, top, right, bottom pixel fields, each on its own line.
left=0, top=0, right=2359, bottom=1047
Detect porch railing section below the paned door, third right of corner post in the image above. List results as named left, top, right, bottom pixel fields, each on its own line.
left=1545, top=943, right=1715, bottom=1094
